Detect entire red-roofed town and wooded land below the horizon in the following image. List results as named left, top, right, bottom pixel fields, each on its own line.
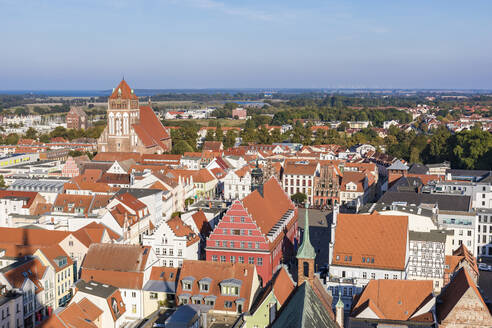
left=0, top=79, right=492, bottom=328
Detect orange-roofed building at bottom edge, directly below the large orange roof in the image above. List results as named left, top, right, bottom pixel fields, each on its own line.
left=349, top=280, right=436, bottom=328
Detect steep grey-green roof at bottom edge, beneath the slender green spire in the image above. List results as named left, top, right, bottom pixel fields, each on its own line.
left=271, top=282, right=338, bottom=328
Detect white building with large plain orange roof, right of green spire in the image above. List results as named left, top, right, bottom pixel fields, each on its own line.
left=326, top=211, right=409, bottom=310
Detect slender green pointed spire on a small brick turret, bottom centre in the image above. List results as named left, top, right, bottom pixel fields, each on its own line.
left=296, top=203, right=316, bottom=286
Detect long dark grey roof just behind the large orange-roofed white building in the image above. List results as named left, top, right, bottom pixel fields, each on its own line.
left=378, top=191, right=470, bottom=212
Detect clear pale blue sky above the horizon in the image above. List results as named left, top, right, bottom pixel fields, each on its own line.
left=0, top=0, right=492, bottom=90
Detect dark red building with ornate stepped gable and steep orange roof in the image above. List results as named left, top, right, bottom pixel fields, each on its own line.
left=206, top=177, right=298, bottom=284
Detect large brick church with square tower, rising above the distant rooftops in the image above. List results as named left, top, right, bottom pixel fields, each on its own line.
left=97, top=79, right=172, bottom=154
